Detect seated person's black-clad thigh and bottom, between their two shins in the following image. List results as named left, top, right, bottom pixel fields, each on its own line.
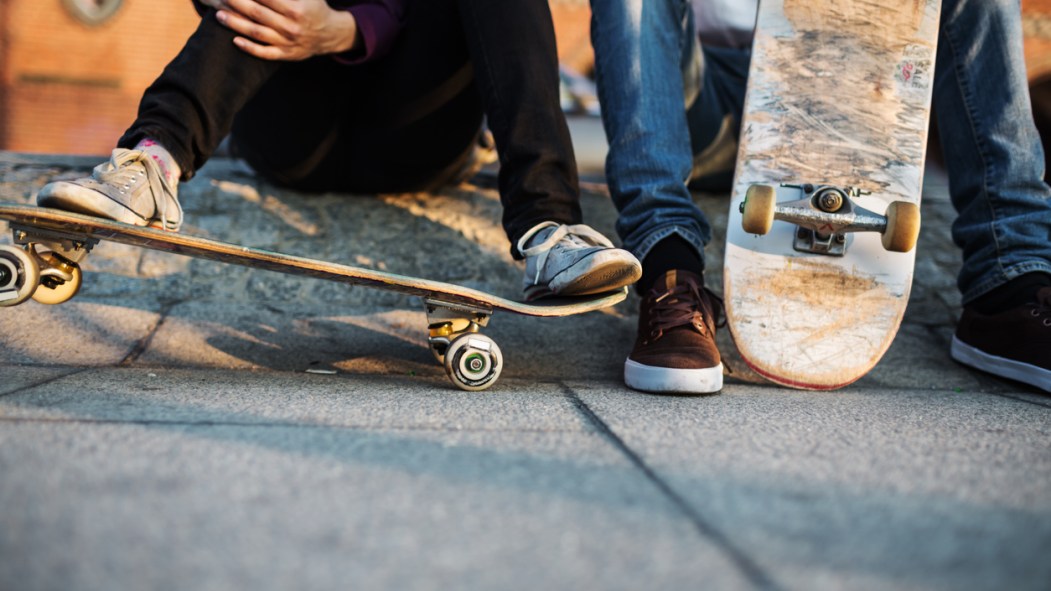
left=232, top=0, right=482, bottom=193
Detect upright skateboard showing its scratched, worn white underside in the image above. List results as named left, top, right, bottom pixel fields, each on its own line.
left=723, top=0, right=940, bottom=390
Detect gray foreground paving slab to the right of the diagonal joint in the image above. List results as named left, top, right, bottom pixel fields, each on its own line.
left=571, top=383, right=1051, bottom=589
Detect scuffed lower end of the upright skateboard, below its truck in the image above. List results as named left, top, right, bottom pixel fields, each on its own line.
left=723, top=245, right=911, bottom=390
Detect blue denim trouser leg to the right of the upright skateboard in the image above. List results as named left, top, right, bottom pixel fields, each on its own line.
left=934, top=0, right=1051, bottom=303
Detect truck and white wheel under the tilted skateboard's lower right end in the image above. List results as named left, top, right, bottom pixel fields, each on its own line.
left=424, top=298, right=503, bottom=391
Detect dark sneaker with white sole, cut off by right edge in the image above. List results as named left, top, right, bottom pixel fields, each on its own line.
left=952, top=287, right=1051, bottom=392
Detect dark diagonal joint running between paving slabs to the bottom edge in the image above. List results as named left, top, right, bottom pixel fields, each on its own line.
left=562, top=383, right=780, bottom=590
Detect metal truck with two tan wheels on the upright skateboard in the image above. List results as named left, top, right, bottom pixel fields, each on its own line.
left=740, top=183, right=920, bottom=252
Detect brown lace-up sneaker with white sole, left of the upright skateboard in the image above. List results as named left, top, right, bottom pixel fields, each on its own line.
left=624, top=270, right=722, bottom=394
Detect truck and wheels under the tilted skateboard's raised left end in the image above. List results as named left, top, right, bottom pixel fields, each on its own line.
left=0, top=224, right=93, bottom=307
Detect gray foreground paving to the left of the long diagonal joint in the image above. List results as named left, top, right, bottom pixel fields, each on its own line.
left=0, top=368, right=748, bottom=589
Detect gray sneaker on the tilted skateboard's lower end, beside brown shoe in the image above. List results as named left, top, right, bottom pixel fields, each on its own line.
left=518, top=222, right=642, bottom=300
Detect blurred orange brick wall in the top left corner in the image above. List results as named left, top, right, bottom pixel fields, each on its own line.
left=0, top=0, right=198, bottom=155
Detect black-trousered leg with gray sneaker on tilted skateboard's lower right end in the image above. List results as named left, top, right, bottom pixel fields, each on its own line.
left=458, top=0, right=640, bottom=299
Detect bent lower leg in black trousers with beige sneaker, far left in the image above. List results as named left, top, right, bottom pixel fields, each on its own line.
left=38, top=14, right=280, bottom=230
